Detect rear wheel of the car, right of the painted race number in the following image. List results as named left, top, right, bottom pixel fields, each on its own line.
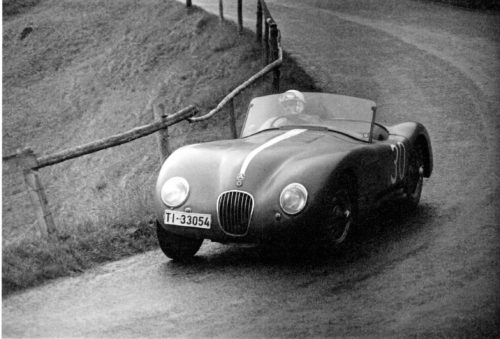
left=404, top=145, right=424, bottom=210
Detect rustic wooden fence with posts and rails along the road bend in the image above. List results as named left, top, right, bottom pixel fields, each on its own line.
left=3, top=0, right=283, bottom=238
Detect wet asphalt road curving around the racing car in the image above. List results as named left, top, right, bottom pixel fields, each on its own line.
left=2, top=0, right=500, bottom=337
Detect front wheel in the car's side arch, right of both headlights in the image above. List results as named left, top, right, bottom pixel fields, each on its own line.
left=321, top=175, right=357, bottom=249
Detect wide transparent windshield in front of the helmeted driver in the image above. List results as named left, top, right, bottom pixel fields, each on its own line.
left=241, top=90, right=375, bottom=141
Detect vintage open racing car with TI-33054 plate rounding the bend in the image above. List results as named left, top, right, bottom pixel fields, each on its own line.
left=155, top=90, right=433, bottom=260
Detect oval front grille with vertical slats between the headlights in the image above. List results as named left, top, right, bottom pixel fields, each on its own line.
left=217, top=191, right=253, bottom=236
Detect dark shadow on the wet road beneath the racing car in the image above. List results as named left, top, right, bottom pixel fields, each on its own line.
left=165, top=203, right=437, bottom=273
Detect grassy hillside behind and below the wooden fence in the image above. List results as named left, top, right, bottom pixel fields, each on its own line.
left=2, top=0, right=312, bottom=294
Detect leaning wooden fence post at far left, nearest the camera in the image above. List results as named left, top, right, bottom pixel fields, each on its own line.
left=17, top=148, right=57, bottom=238
